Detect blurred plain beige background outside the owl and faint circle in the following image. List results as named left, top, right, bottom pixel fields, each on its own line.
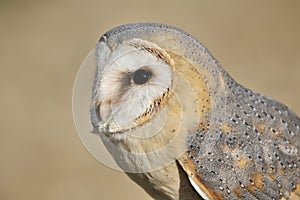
left=0, top=0, right=300, bottom=200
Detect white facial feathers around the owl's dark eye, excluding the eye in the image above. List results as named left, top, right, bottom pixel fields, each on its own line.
left=95, top=39, right=173, bottom=132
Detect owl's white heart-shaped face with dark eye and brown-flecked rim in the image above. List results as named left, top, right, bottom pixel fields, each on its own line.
left=91, top=39, right=174, bottom=134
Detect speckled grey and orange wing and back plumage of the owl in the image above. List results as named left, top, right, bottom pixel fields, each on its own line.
left=188, top=79, right=300, bottom=199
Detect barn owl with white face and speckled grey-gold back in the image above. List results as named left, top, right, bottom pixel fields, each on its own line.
left=90, top=23, right=300, bottom=200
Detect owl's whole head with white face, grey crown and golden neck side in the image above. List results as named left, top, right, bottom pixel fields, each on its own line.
left=90, top=23, right=225, bottom=170
